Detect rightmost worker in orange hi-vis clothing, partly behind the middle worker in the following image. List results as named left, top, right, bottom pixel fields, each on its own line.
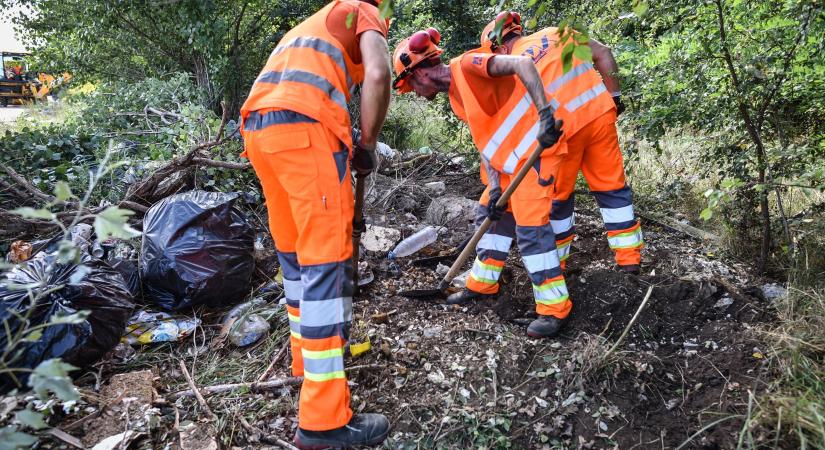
left=481, top=11, right=644, bottom=274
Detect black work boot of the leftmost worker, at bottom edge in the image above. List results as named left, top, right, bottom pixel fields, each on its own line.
left=293, top=414, right=390, bottom=450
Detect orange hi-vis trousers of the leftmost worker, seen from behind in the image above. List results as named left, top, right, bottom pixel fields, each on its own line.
left=243, top=110, right=354, bottom=431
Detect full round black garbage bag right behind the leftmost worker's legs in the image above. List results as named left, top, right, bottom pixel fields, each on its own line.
left=140, top=191, right=255, bottom=311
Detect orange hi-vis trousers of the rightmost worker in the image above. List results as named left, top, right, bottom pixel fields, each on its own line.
left=550, top=110, right=644, bottom=267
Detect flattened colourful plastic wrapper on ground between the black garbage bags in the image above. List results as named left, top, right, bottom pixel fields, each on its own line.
left=122, top=311, right=201, bottom=345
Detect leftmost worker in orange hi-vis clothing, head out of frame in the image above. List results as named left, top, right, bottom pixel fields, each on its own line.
left=241, top=0, right=392, bottom=448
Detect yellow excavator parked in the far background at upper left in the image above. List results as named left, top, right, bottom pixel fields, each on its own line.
left=0, top=51, right=72, bottom=106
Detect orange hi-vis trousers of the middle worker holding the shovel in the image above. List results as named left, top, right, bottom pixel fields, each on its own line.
left=467, top=155, right=573, bottom=319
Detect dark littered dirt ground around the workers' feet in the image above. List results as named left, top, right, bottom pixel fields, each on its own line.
left=53, top=154, right=772, bottom=449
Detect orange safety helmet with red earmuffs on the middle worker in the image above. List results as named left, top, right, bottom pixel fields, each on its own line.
left=392, top=27, right=443, bottom=94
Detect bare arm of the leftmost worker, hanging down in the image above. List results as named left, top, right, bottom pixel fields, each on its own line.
left=359, top=31, right=392, bottom=150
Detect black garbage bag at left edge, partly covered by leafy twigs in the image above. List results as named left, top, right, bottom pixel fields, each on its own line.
left=0, top=255, right=134, bottom=392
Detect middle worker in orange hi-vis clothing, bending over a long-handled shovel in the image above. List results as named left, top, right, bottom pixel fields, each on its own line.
left=393, top=28, right=572, bottom=337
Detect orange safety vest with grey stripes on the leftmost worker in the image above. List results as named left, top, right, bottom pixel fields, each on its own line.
left=241, top=0, right=364, bottom=148
